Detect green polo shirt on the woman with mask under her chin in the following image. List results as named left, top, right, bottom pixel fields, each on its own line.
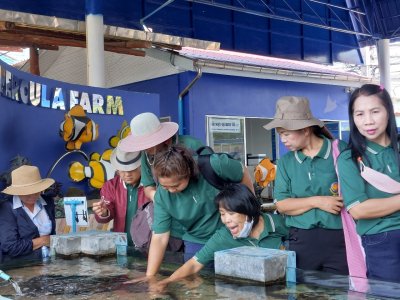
left=194, top=214, right=289, bottom=265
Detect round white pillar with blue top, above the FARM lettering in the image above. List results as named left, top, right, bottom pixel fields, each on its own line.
left=86, top=0, right=106, bottom=87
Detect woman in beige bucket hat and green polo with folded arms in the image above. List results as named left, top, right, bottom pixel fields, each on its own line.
left=264, top=96, right=348, bottom=274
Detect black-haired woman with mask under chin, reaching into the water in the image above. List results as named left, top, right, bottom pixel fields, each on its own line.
left=153, top=184, right=289, bottom=290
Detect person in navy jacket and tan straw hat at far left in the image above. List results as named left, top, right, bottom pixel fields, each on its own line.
left=0, top=165, right=56, bottom=261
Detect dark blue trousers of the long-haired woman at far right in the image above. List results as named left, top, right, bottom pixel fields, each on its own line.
left=361, top=230, right=400, bottom=282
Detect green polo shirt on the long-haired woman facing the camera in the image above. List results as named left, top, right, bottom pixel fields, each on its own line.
left=338, top=141, right=400, bottom=235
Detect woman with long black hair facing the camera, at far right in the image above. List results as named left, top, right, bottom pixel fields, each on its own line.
left=338, top=84, right=400, bottom=282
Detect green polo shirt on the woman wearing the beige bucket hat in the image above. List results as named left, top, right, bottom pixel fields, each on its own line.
left=274, top=137, right=346, bottom=229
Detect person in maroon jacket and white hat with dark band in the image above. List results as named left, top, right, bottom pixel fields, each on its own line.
left=93, top=144, right=150, bottom=245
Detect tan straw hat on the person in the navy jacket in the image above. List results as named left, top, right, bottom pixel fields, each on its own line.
left=3, top=165, right=54, bottom=196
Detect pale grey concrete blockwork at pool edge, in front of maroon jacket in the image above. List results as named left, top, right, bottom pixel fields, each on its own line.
left=50, top=231, right=126, bottom=256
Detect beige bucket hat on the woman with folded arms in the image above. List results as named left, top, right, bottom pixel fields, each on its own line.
left=263, top=96, right=324, bottom=130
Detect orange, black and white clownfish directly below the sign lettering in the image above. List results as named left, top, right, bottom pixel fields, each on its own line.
left=60, top=105, right=99, bottom=151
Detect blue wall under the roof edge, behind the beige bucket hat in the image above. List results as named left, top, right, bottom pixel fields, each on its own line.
left=188, top=74, right=348, bottom=137
